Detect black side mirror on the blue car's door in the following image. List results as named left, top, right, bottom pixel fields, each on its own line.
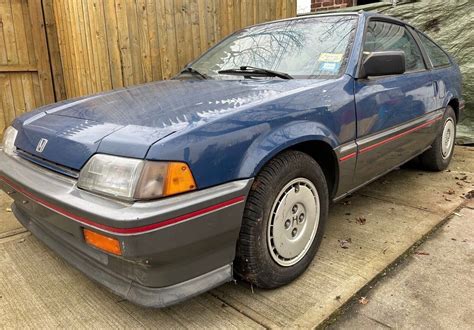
left=359, top=50, right=405, bottom=78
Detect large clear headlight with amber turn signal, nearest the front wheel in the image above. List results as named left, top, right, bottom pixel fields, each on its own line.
left=77, top=155, right=196, bottom=201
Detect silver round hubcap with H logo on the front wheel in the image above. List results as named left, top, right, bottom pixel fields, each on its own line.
left=267, top=178, right=320, bottom=267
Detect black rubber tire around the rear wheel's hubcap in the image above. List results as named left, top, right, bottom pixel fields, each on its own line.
left=419, top=105, right=456, bottom=172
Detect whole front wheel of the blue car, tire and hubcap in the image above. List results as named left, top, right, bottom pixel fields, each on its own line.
left=235, top=151, right=328, bottom=288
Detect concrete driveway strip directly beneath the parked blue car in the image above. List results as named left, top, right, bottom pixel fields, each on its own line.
left=0, top=147, right=474, bottom=328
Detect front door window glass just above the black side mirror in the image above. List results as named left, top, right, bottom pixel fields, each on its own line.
left=364, top=21, right=425, bottom=72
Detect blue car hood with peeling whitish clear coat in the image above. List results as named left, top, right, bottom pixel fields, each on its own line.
left=16, top=79, right=323, bottom=169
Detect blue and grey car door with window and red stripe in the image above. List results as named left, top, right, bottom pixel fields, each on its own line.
left=354, top=19, right=435, bottom=186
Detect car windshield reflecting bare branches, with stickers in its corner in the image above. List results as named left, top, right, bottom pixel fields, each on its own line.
left=191, top=16, right=357, bottom=79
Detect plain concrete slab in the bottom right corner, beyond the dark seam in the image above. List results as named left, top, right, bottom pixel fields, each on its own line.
left=328, top=205, right=474, bottom=330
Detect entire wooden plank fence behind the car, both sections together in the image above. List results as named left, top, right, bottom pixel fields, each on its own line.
left=0, top=0, right=296, bottom=133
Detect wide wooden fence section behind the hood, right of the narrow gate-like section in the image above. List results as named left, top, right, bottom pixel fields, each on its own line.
left=51, top=0, right=296, bottom=97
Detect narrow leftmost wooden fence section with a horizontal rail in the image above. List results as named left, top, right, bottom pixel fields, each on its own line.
left=0, top=0, right=55, bottom=135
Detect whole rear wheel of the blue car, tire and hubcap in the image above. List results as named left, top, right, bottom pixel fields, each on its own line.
left=420, top=105, right=456, bottom=171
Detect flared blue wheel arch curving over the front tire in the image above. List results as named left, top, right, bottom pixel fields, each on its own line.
left=239, top=121, right=339, bottom=178
